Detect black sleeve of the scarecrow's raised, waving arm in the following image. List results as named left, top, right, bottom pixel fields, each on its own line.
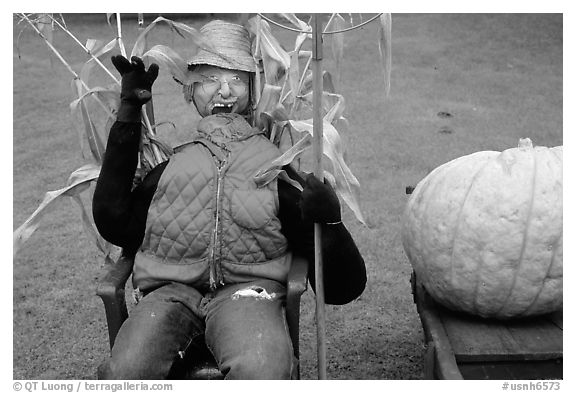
left=92, top=121, right=166, bottom=255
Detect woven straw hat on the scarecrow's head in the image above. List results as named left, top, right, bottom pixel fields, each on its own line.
left=188, top=20, right=256, bottom=72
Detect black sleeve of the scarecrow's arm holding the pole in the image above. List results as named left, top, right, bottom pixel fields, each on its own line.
left=278, top=167, right=366, bottom=304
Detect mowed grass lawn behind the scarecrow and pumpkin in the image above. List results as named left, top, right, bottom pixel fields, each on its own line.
left=13, top=14, right=563, bottom=379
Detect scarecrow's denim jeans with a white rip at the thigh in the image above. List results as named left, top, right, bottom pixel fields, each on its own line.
left=98, top=280, right=297, bottom=379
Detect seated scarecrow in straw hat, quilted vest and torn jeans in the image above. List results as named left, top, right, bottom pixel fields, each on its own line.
left=93, top=21, right=366, bottom=379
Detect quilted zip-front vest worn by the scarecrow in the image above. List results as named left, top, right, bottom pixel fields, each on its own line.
left=133, top=114, right=291, bottom=291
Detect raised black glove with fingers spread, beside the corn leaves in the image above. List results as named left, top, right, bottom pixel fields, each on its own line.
left=112, top=55, right=158, bottom=123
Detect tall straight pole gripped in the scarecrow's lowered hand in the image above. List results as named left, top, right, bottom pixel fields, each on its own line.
left=312, top=14, right=326, bottom=379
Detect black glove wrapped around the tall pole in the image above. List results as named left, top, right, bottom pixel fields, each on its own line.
left=300, top=174, right=342, bottom=224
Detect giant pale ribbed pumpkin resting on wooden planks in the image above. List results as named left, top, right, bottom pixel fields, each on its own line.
left=402, top=139, right=562, bottom=319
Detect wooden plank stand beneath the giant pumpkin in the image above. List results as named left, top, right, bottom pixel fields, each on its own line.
left=411, top=274, right=562, bottom=379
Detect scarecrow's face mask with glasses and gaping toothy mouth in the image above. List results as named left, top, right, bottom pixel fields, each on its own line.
left=192, top=65, right=250, bottom=117
